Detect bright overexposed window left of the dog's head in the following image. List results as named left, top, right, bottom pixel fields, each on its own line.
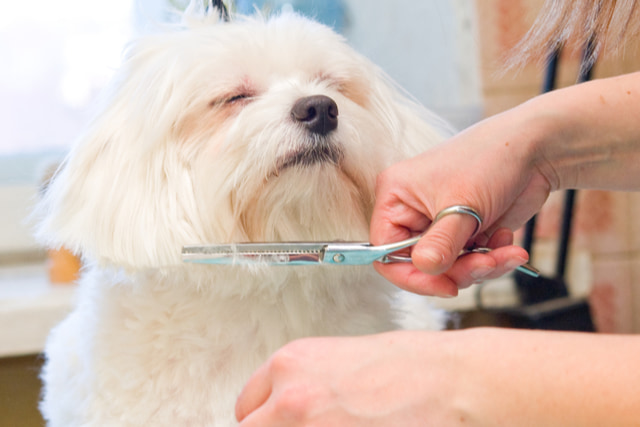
left=0, top=0, right=133, bottom=257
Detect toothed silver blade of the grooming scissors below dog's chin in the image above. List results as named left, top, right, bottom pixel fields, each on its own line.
left=182, top=242, right=327, bottom=265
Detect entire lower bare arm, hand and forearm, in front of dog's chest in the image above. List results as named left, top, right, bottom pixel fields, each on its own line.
left=236, top=328, right=640, bottom=427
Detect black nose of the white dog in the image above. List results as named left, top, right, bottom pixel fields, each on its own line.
left=291, top=95, right=338, bottom=135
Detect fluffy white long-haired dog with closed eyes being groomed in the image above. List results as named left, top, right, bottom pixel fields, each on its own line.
left=38, top=4, right=450, bottom=427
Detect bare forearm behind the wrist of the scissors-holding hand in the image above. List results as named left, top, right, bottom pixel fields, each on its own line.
left=528, top=73, right=640, bottom=190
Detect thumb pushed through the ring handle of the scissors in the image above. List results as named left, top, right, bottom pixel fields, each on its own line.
left=411, top=214, right=477, bottom=275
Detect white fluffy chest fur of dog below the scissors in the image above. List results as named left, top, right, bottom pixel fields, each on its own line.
left=41, top=267, right=395, bottom=426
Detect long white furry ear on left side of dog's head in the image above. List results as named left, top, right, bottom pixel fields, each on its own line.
left=35, top=41, right=205, bottom=268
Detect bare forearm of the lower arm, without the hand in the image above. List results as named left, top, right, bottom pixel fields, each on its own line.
left=449, top=329, right=640, bottom=427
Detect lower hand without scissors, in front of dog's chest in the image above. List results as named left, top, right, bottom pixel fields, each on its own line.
left=236, top=331, right=466, bottom=427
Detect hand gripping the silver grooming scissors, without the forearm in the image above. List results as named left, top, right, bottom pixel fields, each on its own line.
left=370, top=104, right=553, bottom=296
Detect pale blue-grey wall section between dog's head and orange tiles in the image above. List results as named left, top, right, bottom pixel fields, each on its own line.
left=344, top=0, right=482, bottom=128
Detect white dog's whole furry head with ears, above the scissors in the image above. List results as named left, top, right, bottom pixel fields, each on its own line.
left=35, top=11, right=439, bottom=268
